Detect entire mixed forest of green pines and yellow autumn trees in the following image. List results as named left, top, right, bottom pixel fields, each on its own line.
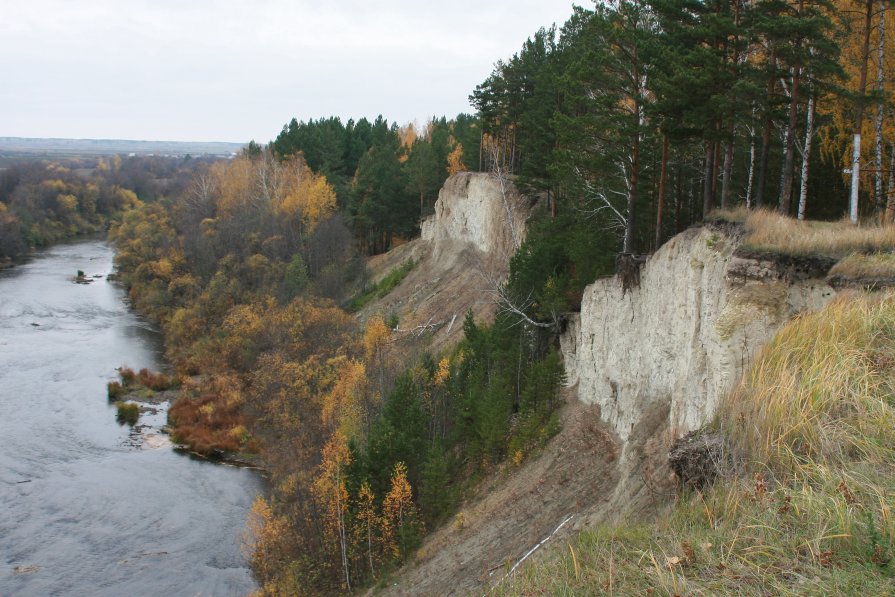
left=12, top=0, right=895, bottom=595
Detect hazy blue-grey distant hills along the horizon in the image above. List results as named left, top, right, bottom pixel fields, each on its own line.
left=0, top=137, right=245, bottom=159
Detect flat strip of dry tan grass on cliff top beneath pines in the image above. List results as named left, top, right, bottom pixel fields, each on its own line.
left=708, top=208, right=895, bottom=259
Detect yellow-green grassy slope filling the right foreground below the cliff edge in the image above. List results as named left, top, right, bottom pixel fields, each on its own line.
left=495, top=293, right=895, bottom=596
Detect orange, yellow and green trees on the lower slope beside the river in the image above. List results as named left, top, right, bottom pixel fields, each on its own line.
left=110, top=141, right=560, bottom=595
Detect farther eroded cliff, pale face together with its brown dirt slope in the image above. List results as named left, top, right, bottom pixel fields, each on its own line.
left=360, top=172, right=530, bottom=352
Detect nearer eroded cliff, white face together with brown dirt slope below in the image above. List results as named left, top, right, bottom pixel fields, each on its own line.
left=383, top=221, right=835, bottom=595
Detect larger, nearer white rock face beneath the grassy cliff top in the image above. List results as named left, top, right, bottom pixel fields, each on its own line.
left=561, top=228, right=834, bottom=441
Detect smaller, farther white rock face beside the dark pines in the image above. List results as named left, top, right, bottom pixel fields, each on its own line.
left=421, top=172, right=529, bottom=263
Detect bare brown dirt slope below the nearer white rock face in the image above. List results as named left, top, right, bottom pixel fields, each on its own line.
left=375, top=388, right=674, bottom=596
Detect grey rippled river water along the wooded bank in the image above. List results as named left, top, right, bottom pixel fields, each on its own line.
left=0, top=241, right=261, bottom=596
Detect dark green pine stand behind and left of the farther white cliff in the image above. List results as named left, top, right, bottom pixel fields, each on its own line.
left=270, top=114, right=481, bottom=254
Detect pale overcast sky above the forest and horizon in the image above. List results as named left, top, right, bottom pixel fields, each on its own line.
left=0, top=0, right=587, bottom=142
